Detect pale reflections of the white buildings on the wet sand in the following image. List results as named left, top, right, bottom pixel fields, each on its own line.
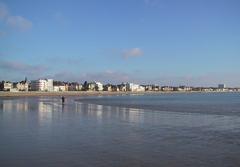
left=0, top=98, right=144, bottom=123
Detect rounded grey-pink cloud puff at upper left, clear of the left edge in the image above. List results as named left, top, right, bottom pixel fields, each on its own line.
left=7, top=16, right=32, bottom=31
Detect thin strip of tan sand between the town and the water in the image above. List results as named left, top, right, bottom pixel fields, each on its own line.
left=0, top=91, right=236, bottom=97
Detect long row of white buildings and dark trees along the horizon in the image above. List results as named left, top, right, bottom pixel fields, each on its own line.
left=0, top=77, right=240, bottom=93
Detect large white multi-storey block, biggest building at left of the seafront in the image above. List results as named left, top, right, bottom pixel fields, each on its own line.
left=30, top=79, right=53, bottom=92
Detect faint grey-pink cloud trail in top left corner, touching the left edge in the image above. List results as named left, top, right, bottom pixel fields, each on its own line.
left=0, top=3, right=32, bottom=31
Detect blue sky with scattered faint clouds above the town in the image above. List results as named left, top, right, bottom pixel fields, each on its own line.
left=0, top=0, right=240, bottom=87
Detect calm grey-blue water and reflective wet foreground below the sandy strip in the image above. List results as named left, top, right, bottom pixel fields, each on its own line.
left=0, top=93, right=240, bottom=167
